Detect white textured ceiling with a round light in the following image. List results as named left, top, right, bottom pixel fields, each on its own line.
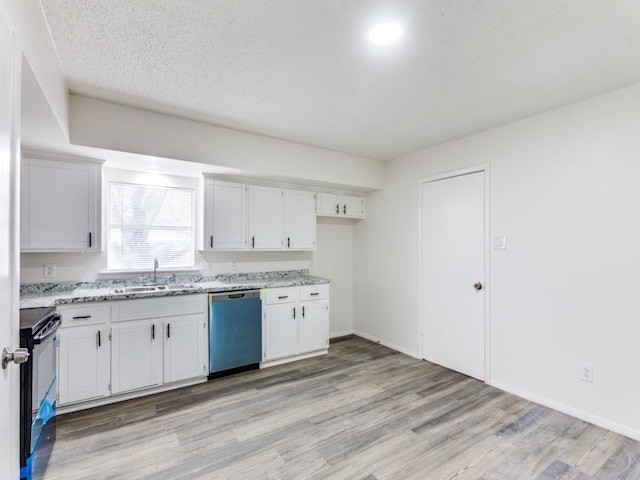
left=41, top=0, right=640, bottom=159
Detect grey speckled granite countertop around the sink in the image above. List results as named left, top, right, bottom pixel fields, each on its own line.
left=20, top=270, right=330, bottom=309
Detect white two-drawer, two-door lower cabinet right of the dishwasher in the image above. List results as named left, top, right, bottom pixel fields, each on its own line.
left=262, top=284, right=329, bottom=362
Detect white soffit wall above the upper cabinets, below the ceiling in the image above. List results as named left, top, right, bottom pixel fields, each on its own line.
left=69, top=95, right=383, bottom=191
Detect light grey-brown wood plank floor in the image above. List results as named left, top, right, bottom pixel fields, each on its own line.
left=45, top=337, right=640, bottom=480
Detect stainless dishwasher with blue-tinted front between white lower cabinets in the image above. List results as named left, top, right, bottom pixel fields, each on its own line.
left=209, top=290, right=262, bottom=379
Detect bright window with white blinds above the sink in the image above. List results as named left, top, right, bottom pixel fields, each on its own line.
left=107, top=181, right=195, bottom=271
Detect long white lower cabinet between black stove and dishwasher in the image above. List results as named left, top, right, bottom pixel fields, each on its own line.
left=58, top=295, right=209, bottom=406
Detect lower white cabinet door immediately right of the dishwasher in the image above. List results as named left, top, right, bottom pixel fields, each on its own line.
left=264, top=303, right=299, bottom=360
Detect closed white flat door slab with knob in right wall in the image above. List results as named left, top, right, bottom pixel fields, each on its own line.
left=420, top=172, right=485, bottom=380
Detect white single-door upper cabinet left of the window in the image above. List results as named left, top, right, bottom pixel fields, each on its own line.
left=20, top=158, right=101, bottom=252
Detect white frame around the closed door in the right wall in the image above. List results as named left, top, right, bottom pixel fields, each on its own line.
left=416, top=163, right=491, bottom=384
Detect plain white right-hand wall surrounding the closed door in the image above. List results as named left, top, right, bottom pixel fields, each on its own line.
left=354, top=80, right=640, bottom=439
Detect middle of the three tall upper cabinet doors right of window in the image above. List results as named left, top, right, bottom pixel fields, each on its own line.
left=248, top=185, right=283, bottom=250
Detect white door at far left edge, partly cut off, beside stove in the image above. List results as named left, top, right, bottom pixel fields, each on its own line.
left=0, top=5, right=20, bottom=479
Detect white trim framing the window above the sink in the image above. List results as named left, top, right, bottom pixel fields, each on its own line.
left=100, top=168, right=202, bottom=275
